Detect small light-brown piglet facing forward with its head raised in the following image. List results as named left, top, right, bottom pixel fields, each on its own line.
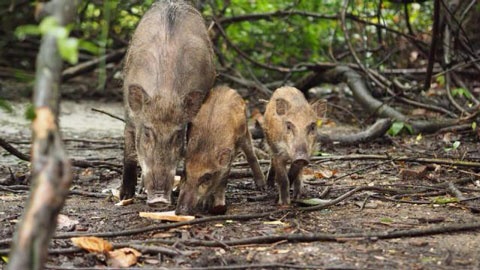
left=263, top=87, right=326, bottom=204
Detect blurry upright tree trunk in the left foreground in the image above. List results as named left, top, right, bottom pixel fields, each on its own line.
left=7, top=0, right=78, bottom=270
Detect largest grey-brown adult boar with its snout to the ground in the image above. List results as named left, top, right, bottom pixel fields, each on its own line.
left=120, top=0, right=215, bottom=206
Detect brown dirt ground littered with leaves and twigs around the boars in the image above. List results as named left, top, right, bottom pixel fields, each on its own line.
left=0, top=98, right=480, bottom=269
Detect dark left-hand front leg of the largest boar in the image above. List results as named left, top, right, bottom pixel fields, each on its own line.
left=120, top=124, right=137, bottom=200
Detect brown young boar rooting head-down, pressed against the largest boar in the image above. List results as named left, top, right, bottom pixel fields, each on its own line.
left=176, top=86, right=265, bottom=214
